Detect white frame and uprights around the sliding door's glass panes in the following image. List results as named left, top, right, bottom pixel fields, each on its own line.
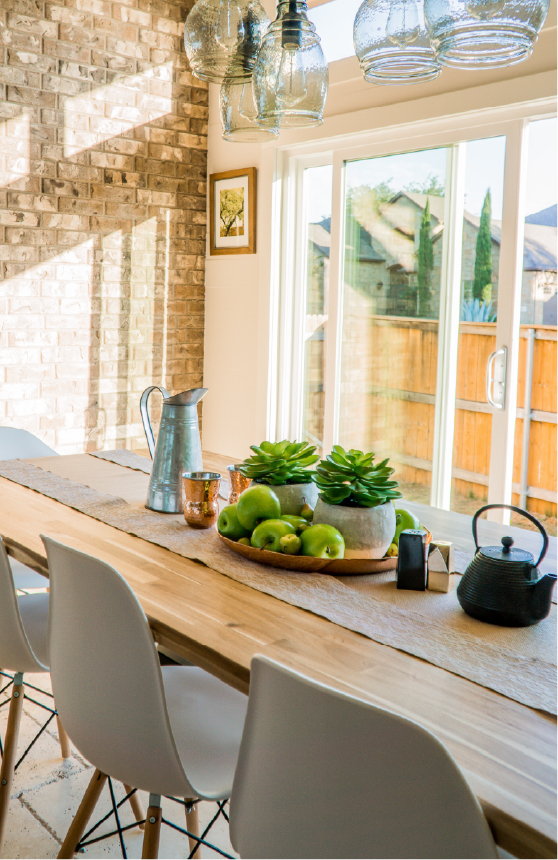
left=269, top=98, right=556, bottom=522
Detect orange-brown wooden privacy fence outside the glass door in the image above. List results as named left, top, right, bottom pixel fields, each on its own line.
left=340, top=315, right=557, bottom=516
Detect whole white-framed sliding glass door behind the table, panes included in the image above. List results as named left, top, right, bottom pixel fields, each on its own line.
left=286, top=110, right=556, bottom=528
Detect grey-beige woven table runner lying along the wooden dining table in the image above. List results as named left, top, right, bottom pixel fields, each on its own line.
left=0, top=452, right=556, bottom=714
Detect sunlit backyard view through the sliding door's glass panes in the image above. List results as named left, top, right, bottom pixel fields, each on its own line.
left=302, top=118, right=557, bottom=534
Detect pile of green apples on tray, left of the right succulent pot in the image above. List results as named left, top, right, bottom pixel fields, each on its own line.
left=217, top=484, right=345, bottom=559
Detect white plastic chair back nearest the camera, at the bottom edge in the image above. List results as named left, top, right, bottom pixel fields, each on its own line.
left=230, top=656, right=498, bottom=858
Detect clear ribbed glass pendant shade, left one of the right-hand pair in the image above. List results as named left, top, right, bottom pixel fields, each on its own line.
left=353, top=0, right=441, bottom=85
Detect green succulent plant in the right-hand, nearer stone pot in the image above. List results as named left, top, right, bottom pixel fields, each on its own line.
left=314, top=445, right=401, bottom=508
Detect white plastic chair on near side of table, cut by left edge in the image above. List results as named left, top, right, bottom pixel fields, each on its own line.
left=0, top=538, right=70, bottom=849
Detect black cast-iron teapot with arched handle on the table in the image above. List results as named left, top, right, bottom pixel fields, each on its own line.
left=457, top=505, right=556, bottom=627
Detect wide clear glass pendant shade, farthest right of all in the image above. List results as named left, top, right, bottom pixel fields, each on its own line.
left=424, top=0, right=549, bottom=69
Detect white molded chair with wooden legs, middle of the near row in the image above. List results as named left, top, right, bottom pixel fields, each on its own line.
left=43, top=537, right=247, bottom=857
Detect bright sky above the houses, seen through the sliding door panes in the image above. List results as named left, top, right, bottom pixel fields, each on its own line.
left=307, top=122, right=557, bottom=227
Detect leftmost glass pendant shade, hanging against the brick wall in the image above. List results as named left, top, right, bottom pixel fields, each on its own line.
left=184, top=0, right=269, bottom=83
